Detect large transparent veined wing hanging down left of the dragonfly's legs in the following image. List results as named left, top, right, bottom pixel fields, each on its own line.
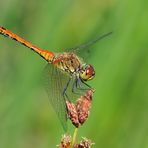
left=44, top=64, right=69, bottom=131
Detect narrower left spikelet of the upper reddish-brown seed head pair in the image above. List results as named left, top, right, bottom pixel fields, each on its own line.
left=66, top=101, right=80, bottom=127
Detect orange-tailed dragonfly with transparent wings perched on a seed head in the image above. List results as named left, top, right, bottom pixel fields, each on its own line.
left=0, top=27, right=112, bottom=131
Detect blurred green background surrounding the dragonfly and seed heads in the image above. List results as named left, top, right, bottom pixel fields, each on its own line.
left=0, top=0, right=148, bottom=148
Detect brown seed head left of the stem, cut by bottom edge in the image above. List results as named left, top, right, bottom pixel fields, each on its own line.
left=59, top=135, right=71, bottom=148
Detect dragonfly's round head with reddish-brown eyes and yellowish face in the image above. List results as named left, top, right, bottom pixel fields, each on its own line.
left=80, top=65, right=95, bottom=81
